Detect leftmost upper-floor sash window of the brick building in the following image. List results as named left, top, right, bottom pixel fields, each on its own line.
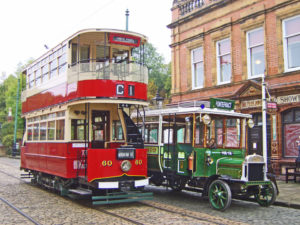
left=192, top=47, right=204, bottom=89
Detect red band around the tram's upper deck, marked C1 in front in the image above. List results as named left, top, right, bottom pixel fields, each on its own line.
left=22, top=80, right=147, bottom=113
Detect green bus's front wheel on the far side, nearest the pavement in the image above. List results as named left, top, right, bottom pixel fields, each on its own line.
left=254, top=181, right=278, bottom=207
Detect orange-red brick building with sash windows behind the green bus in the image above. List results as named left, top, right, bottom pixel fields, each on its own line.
left=168, top=0, right=300, bottom=174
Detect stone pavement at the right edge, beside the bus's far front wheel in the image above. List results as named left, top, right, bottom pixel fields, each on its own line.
left=274, top=177, right=300, bottom=209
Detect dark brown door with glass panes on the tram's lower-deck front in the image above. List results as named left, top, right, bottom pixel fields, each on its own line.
left=92, top=110, right=110, bottom=148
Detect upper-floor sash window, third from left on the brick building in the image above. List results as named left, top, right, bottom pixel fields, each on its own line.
left=247, top=28, right=265, bottom=79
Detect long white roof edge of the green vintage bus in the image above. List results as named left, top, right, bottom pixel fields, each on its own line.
left=137, top=107, right=252, bottom=118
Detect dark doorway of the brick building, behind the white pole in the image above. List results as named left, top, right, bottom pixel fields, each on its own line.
left=248, top=113, right=271, bottom=161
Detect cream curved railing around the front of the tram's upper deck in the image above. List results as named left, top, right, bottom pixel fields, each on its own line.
left=68, top=59, right=148, bottom=84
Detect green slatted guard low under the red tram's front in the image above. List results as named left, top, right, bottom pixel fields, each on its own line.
left=92, top=192, right=153, bottom=205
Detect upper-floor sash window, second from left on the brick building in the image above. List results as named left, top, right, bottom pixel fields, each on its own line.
left=217, top=38, right=231, bottom=84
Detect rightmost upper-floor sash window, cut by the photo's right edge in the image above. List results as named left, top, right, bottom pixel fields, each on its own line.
left=283, top=15, right=300, bottom=72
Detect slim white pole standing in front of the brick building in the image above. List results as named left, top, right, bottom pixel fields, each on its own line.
left=261, top=73, right=268, bottom=172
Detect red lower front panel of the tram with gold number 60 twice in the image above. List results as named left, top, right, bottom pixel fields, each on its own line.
left=87, top=149, right=147, bottom=182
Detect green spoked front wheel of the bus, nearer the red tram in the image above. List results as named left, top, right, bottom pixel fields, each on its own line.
left=208, top=180, right=231, bottom=211
